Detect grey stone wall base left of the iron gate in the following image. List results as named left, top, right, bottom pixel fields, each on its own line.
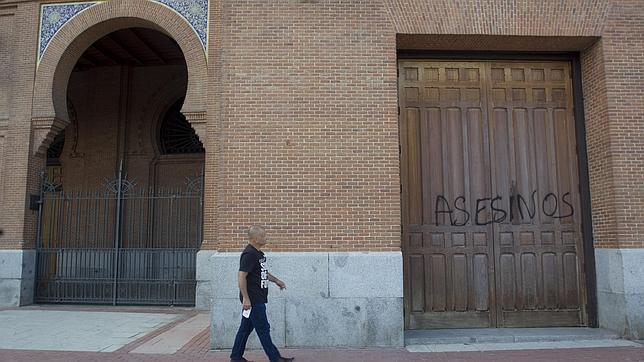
left=0, top=250, right=36, bottom=307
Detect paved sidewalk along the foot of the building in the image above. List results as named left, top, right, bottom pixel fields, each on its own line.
left=0, top=310, right=644, bottom=362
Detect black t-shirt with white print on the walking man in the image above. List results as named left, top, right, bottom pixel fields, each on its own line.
left=239, top=244, right=268, bottom=305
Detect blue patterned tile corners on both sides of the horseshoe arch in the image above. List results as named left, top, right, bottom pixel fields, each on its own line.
left=38, top=0, right=210, bottom=61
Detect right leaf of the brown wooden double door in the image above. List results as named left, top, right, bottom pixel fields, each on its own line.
left=488, top=62, right=585, bottom=326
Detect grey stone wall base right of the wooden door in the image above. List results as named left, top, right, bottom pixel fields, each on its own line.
left=595, top=249, right=644, bottom=339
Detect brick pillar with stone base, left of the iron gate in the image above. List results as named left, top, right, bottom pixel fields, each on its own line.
left=0, top=3, right=38, bottom=306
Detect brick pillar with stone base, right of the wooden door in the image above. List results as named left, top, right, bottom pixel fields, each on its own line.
left=582, top=1, right=644, bottom=339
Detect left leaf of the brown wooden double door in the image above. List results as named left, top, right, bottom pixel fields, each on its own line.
left=399, top=62, right=495, bottom=329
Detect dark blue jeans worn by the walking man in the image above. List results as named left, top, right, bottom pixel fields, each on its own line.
left=230, top=304, right=281, bottom=362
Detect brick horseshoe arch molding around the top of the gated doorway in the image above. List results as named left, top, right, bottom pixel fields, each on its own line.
left=32, top=0, right=208, bottom=155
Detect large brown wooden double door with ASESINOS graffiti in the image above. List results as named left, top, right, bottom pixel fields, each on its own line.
left=399, top=61, right=586, bottom=329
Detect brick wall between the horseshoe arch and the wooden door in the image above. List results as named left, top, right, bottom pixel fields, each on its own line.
left=211, top=0, right=400, bottom=251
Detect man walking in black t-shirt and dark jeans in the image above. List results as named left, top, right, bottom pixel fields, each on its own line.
left=230, top=226, right=294, bottom=362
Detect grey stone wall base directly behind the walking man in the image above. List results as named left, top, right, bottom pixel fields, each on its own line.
left=197, top=250, right=404, bottom=349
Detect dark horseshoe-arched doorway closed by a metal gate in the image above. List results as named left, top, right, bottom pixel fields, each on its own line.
left=36, top=27, right=205, bottom=305
